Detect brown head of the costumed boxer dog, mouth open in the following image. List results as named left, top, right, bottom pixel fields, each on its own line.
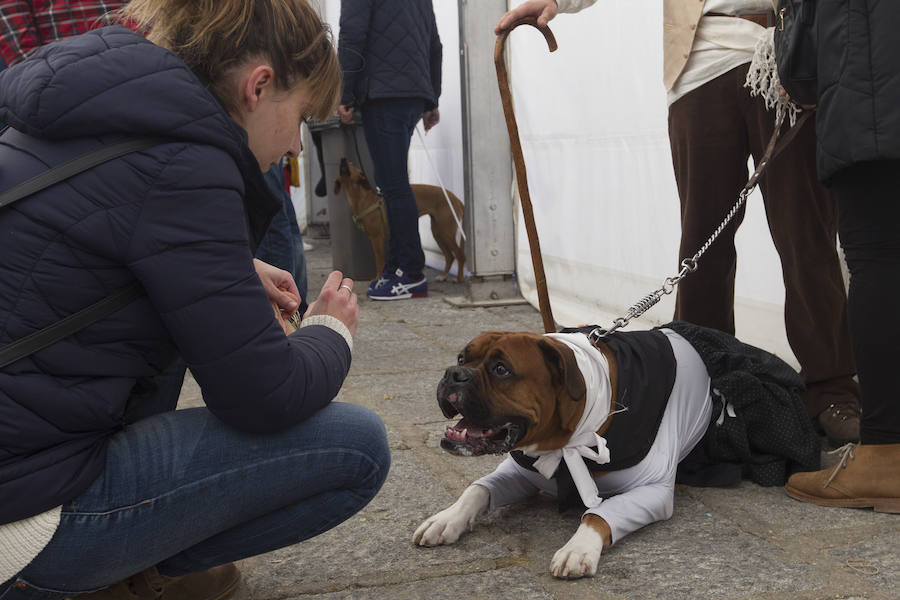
left=437, top=331, right=586, bottom=456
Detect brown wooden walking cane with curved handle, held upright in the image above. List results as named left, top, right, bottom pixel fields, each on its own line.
left=494, top=17, right=556, bottom=333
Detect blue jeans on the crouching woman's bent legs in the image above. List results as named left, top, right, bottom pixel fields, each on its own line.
left=0, top=402, right=390, bottom=600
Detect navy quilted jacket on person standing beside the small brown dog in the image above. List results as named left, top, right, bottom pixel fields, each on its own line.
left=338, top=0, right=442, bottom=110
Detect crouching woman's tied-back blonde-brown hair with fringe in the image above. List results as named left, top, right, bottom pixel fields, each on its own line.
left=119, top=0, right=341, bottom=120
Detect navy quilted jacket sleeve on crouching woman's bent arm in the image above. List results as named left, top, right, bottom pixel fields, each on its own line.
left=127, top=145, right=350, bottom=432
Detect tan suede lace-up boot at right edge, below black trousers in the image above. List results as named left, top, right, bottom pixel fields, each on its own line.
left=784, top=444, right=900, bottom=513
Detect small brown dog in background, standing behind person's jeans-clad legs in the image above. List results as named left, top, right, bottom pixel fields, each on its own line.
left=334, top=158, right=466, bottom=282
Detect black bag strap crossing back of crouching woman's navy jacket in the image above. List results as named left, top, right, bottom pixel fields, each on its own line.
left=0, top=128, right=169, bottom=368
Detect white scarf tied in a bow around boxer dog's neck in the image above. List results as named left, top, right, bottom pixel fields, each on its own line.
left=522, top=333, right=612, bottom=508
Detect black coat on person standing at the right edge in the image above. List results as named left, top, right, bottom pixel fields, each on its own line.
left=816, top=0, right=900, bottom=181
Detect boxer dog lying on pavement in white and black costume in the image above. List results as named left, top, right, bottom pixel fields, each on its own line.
left=413, top=322, right=819, bottom=578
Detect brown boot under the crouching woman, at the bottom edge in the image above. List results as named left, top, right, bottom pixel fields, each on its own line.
left=72, top=563, right=241, bottom=600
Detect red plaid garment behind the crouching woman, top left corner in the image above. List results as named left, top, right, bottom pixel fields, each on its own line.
left=0, top=0, right=127, bottom=65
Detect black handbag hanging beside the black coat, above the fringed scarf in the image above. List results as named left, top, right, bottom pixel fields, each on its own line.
left=775, top=0, right=818, bottom=104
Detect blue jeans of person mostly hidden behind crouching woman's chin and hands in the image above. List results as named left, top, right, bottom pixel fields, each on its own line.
left=256, top=166, right=307, bottom=304
